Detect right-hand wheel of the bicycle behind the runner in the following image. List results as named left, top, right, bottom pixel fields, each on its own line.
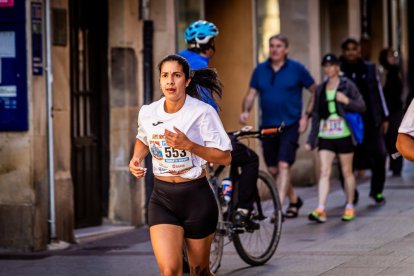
left=233, top=171, right=282, bottom=266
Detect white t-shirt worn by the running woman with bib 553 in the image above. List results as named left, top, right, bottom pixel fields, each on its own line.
left=136, top=95, right=232, bottom=179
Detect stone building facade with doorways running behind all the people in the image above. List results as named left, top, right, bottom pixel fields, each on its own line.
left=0, top=0, right=412, bottom=251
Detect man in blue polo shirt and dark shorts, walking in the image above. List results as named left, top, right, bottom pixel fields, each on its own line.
left=240, top=34, right=316, bottom=218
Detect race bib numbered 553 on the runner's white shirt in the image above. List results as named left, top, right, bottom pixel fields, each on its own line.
left=149, top=134, right=193, bottom=174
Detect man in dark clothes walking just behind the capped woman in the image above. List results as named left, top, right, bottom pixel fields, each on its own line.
left=341, top=38, right=388, bottom=205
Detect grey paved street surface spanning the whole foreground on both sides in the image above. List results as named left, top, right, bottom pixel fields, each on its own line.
left=0, top=162, right=414, bottom=276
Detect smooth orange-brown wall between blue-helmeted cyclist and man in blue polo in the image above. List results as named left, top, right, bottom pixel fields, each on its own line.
left=205, top=0, right=256, bottom=134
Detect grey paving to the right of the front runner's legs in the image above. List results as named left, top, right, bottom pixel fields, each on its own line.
left=217, top=162, right=414, bottom=276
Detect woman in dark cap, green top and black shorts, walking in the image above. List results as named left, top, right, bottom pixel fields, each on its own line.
left=305, top=54, right=366, bottom=222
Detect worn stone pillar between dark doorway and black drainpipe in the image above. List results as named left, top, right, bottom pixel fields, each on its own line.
left=108, top=0, right=143, bottom=225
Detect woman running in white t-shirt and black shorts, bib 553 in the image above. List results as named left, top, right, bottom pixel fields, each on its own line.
left=129, top=55, right=231, bottom=275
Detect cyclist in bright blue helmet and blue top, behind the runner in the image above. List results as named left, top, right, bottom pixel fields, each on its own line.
left=178, top=20, right=259, bottom=226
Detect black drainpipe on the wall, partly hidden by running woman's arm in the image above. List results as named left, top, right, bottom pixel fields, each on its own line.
left=140, top=0, right=154, bottom=222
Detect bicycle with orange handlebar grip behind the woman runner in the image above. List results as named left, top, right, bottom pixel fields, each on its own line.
left=209, top=125, right=283, bottom=273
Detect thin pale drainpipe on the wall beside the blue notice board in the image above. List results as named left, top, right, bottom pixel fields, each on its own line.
left=45, top=0, right=56, bottom=242
